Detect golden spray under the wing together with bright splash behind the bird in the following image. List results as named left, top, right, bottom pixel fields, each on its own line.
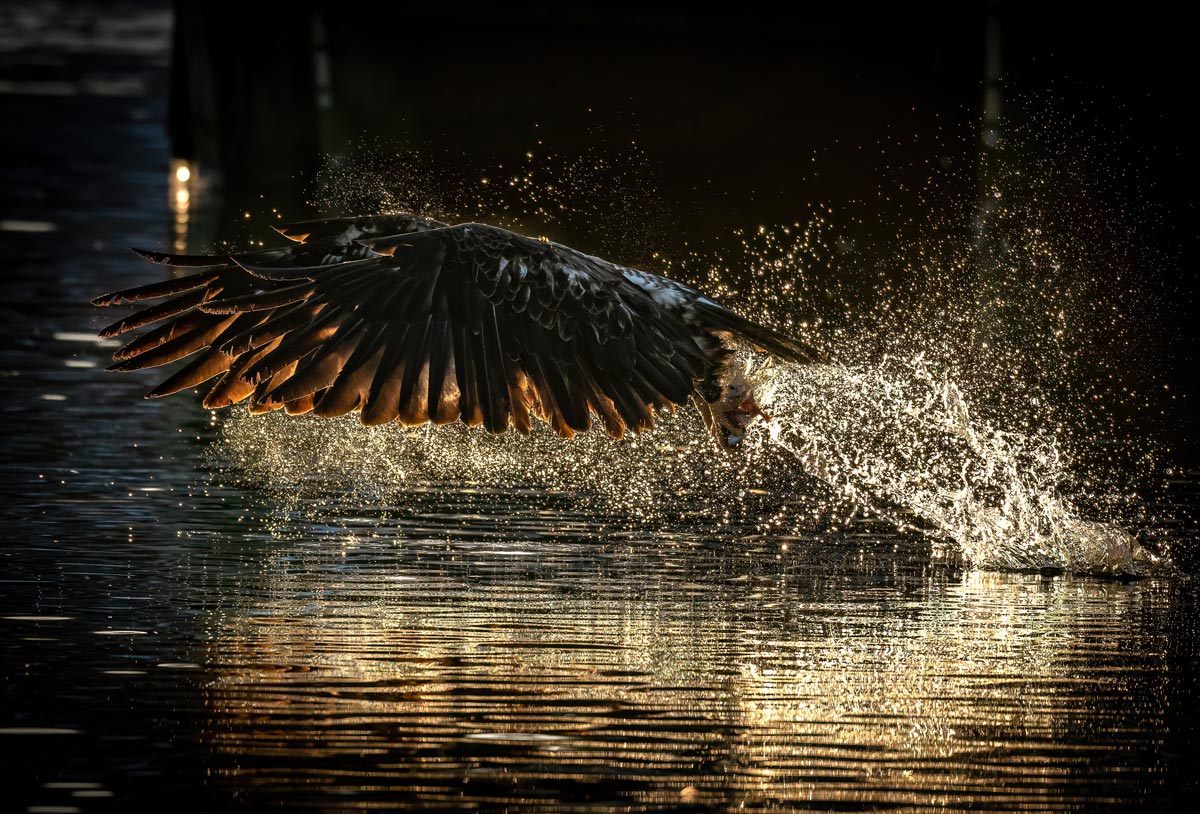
left=217, top=348, right=1157, bottom=575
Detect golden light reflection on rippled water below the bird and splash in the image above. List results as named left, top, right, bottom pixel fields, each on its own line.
left=202, top=538, right=1166, bottom=810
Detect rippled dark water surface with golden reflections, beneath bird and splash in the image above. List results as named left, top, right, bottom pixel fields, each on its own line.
left=0, top=3, right=1200, bottom=812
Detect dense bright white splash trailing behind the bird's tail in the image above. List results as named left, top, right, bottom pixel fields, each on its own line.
left=764, top=355, right=1156, bottom=574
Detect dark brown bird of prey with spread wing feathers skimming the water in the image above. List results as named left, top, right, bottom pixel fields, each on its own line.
left=94, top=215, right=820, bottom=448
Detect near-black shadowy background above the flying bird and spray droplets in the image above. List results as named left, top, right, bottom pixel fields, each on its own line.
left=0, top=2, right=1200, bottom=468
